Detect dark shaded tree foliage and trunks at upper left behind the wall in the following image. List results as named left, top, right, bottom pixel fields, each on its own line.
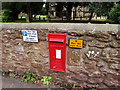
left=2, top=2, right=44, bottom=21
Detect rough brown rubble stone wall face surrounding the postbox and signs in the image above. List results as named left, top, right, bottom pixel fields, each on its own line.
left=1, top=24, right=120, bottom=88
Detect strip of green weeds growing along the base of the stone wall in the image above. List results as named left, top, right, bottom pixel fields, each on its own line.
left=2, top=71, right=119, bottom=90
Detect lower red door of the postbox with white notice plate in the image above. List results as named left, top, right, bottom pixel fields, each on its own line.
left=50, top=47, right=65, bottom=72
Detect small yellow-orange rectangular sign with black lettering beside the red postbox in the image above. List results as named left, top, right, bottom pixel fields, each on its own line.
left=69, top=39, right=83, bottom=48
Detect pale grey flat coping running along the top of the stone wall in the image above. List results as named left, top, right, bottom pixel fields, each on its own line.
left=0, top=23, right=119, bottom=32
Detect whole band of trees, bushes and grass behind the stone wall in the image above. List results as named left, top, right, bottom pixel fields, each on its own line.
left=0, top=2, right=120, bottom=23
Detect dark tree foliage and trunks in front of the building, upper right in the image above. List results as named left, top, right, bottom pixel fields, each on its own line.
left=56, top=2, right=114, bottom=21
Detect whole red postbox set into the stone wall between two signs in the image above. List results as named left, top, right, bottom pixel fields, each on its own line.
left=48, top=34, right=66, bottom=72
